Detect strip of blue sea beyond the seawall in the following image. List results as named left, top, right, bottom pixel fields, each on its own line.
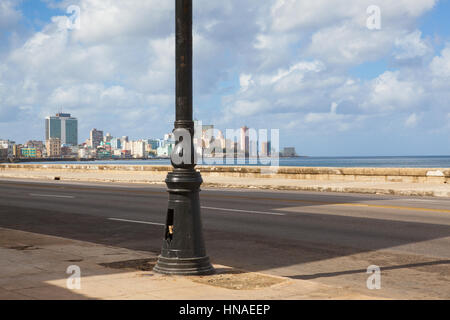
left=40, top=156, right=450, bottom=168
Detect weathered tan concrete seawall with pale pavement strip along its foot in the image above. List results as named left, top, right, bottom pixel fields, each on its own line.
left=0, top=164, right=450, bottom=197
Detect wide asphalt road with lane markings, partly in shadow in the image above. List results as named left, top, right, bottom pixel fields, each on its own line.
left=0, top=180, right=450, bottom=299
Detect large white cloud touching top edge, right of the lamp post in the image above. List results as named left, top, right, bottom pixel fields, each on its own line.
left=270, top=0, right=435, bottom=65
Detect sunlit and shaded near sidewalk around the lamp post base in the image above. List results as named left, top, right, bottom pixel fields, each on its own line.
left=0, top=228, right=380, bottom=300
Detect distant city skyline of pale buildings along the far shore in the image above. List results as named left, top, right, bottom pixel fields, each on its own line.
left=0, top=111, right=288, bottom=163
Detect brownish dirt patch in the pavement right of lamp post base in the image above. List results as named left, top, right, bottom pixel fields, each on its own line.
left=190, top=268, right=288, bottom=290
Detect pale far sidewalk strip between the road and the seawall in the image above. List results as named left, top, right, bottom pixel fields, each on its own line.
left=0, top=170, right=450, bottom=197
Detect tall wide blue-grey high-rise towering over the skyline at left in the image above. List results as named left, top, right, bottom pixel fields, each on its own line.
left=45, top=113, right=78, bottom=146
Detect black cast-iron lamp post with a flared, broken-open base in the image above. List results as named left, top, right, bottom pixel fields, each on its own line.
left=154, top=0, right=214, bottom=275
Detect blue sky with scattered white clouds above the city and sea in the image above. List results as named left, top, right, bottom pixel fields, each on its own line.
left=0, top=0, right=450, bottom=156
